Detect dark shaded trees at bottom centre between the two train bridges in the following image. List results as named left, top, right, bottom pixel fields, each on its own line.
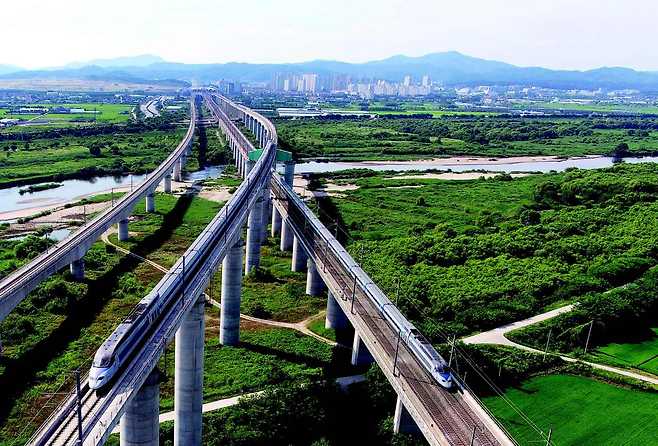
left=152, top=369, right=424, bottom=446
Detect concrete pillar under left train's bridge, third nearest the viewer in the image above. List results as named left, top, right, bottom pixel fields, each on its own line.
left=219, top=239, right=242, bottom=345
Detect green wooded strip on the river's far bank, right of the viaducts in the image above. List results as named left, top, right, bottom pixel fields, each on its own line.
left=276, top=116, right=658, bottom=160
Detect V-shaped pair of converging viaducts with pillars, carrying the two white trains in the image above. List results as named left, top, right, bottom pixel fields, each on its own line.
left=24, top=92, right=514, bottom=446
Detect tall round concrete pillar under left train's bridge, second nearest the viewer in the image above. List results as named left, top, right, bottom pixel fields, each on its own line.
left=174, top=295, right=205, bottom=446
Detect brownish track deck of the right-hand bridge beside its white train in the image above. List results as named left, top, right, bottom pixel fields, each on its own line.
left=272, top=175, right=513, bottom=446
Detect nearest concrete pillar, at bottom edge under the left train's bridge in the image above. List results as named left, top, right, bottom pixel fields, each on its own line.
left=119, top=368, right=160, bottom=446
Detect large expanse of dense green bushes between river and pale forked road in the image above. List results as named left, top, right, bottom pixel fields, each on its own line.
left=329, top=164, right=658, bottom=334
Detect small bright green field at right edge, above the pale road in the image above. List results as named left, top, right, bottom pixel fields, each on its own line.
left=590, top=327, right=658, bottom=375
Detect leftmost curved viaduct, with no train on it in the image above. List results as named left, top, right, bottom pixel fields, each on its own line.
left=0, top=95, right=196, bottom=321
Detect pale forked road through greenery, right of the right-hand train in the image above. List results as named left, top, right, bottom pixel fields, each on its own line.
left=462, top=305, right=658, bottom=385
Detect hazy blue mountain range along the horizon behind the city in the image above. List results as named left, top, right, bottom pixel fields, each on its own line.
left=0, top=51, right=658, bottom=92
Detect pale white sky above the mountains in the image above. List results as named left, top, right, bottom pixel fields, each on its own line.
left=5, top=0, right=658, bottom=71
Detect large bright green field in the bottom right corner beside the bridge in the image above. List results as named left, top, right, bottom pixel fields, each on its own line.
left=484, top=375, right=658, bottom=446
